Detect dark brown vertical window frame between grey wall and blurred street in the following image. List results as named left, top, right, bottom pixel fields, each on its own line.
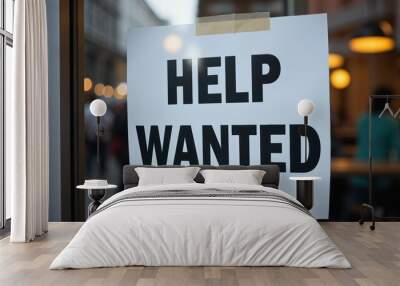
left=59, top=0, right=86, bottom=221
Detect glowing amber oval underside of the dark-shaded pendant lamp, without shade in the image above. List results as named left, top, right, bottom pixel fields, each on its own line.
left=350, top=36, right=395, bottom=54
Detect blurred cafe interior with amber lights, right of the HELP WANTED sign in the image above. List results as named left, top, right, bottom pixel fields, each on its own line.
left=308, top=0, right=400, bottom=220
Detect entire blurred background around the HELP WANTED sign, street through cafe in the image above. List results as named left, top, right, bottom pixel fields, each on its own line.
left=84, top=0, right=400, bottom=220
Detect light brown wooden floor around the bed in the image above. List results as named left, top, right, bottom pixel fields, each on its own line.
left=0, top=222, right=400, bottom=286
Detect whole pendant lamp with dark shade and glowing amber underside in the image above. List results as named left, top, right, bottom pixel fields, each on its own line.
left=349, top=23, right=395, bottom=54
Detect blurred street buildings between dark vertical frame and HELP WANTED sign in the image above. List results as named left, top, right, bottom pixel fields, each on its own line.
left=83, top=0, right=165, bottom=192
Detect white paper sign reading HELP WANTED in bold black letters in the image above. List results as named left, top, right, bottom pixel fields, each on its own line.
left=128, top=14, right=331, bottom=218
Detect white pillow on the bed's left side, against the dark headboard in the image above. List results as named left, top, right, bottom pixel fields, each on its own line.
left=135, top=167, right=200, bottom=186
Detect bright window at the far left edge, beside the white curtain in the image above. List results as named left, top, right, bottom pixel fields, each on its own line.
left=0, top=0, right=14, bottom=228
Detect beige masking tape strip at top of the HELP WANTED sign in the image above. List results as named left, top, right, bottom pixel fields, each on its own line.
left=196, top=12, right=271, bottom=36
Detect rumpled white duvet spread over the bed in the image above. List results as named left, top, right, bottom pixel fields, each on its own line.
left=50, top=183, right=351, bottom=269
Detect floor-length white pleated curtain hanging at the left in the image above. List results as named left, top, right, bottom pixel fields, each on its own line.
left=6, top=0, right=49, bottom=242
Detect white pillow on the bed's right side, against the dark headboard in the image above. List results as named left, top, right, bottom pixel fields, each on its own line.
left=200, top=170, right=265, bottom=185
